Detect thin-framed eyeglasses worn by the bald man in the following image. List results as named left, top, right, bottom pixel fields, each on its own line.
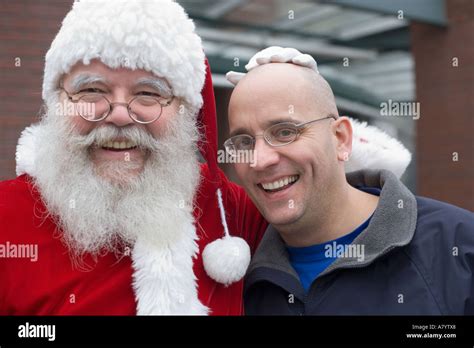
left=224, top=115, right=336, bottom=156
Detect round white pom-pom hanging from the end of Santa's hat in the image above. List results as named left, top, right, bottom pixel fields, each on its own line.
left=202, top=236, right=250, bottom=286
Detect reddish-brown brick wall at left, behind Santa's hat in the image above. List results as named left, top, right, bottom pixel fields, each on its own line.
left=0, top=0, right=72, bottom=180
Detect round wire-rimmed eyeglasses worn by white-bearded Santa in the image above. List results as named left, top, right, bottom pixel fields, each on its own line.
left=60, top=87, right=174, bottom=124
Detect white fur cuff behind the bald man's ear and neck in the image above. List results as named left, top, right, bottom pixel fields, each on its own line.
left=345, top=119, right=411, bottom=178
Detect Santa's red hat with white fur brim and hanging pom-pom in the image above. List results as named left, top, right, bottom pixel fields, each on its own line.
left=38, top=0, right=250, bottom=285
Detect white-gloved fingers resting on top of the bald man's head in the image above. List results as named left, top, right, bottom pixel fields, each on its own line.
left=226, top=46, right=318, bottom=86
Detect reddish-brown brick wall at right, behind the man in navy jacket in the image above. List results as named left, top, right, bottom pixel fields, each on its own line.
left=411, top=0, right=474, bottom=210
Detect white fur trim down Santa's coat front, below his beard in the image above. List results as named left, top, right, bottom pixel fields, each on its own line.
left=132, top=217, right=209, bottom=315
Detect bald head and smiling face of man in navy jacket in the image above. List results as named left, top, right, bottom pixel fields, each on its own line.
left=228, top=63, right=352, bottom=239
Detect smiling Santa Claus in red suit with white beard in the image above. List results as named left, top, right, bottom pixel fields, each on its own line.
left=0, top=0, right=409, bottom=315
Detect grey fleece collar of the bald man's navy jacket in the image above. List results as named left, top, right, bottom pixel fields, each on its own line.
left=246, top=170, right=417, bottom=288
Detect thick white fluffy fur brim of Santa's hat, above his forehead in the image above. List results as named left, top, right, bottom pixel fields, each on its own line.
left=43, top=0, right=205, bottom=108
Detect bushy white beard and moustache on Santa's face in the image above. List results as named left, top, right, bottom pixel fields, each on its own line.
left=34, top=100, right=200, bottom=262
